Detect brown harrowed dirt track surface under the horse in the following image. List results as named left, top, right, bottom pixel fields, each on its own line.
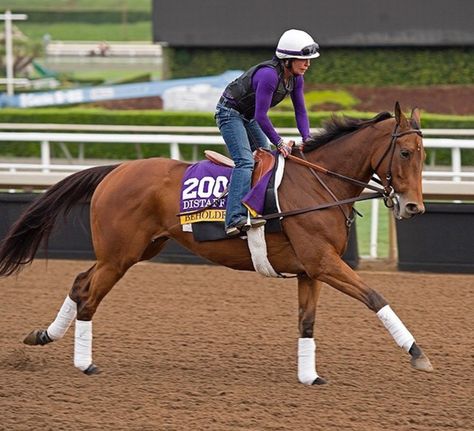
left=0, top=260, right=474, bottom=431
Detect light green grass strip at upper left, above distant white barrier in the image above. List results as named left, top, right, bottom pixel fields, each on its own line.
left=18, top=20, right=152, bottom=41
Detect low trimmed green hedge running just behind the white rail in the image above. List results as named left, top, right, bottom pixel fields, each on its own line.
left=0, top=108, right=474, bottom=165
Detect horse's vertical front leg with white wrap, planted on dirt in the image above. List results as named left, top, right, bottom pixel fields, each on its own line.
left=298, top=275, right=326, bottom=385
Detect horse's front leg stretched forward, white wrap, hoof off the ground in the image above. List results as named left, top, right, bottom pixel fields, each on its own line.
left=319, top=255, right=433, bottom=371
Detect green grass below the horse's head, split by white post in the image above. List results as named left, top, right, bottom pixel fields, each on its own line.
left=356, top=201, right=392, bottom=258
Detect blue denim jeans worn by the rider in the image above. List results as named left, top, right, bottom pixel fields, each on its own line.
left=215, top=103, right=270, bottom=227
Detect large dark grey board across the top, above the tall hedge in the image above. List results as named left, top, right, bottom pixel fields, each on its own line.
left=153, top=0, right=474, bottom=47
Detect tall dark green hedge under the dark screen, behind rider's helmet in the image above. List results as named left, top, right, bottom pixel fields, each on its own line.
left=169, top=47, right=474, bottom=86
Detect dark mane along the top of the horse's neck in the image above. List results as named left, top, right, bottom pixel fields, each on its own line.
left=303, top=112, right=392, bottom=153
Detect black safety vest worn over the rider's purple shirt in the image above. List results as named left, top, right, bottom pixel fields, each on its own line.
left=224, top=58, right=295, bottom=119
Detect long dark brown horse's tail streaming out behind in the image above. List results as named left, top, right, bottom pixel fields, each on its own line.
left=0, top=165, right=119, bottom=277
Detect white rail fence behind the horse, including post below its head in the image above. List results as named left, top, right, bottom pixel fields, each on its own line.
left=0, top=129, right=474, bottom=258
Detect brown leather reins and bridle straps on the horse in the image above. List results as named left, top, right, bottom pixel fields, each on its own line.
left=259, top=124, right=423, bottom=228
